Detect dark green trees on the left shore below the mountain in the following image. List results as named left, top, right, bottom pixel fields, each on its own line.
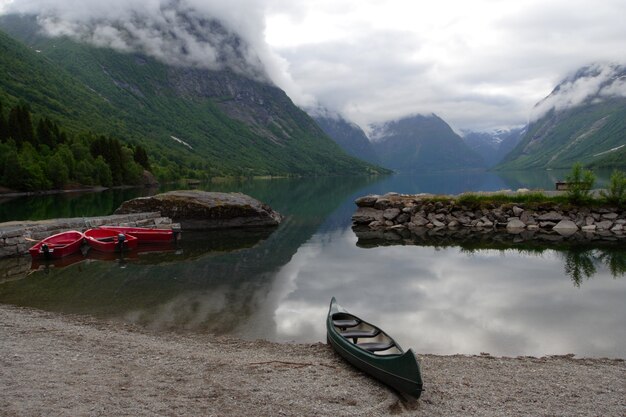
left=0, top=102, right=151, bottom=191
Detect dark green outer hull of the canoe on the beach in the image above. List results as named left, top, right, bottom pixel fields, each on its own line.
left=326, top=298, right=423, bottom=398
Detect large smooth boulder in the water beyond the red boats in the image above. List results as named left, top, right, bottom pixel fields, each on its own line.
left=115, top=190, right=282, bottom=230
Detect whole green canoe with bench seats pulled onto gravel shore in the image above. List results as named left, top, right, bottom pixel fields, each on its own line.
left=326, top=297, right=422, bottom=398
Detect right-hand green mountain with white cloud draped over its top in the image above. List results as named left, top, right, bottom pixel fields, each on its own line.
left=498, top=64, right=626, bottom=169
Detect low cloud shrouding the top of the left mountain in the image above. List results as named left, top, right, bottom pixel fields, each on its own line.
left=4, top=0, right=312, bottom=104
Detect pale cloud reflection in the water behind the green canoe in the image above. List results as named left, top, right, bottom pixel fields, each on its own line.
left=274, top=229, right=626, bottom=357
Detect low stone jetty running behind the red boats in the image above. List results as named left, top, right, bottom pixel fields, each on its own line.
left=0, top=212, right=177, bottom=258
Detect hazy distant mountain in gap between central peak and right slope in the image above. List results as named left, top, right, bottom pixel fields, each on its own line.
left=463, top=128, right=525, bottom=167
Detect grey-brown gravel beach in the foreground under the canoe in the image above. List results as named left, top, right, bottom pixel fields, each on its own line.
left=0, top=305, right=626, bottom=417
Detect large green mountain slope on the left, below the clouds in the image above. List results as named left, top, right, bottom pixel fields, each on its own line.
left=0, top=16, right=381, bottom=176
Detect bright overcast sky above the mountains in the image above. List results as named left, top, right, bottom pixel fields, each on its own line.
left=0, top=0, right=626, bottom=130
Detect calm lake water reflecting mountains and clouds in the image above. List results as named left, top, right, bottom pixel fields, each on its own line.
left=0, top=171, right=626, bottom=358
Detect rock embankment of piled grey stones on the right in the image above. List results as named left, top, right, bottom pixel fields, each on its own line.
left=352, top=193, right=626, bottom=240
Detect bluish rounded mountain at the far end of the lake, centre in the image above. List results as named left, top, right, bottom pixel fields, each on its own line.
left=370, top=114, right=486, bottom=171
